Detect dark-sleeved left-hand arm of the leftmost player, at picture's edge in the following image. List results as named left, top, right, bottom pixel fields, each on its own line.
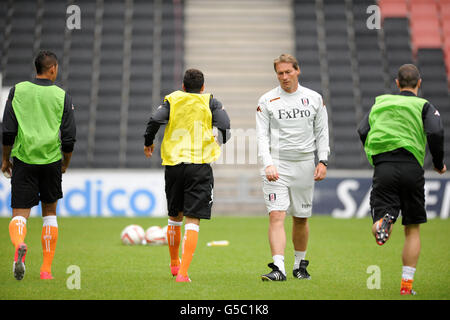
left=2, top=87, right=19, bottom=177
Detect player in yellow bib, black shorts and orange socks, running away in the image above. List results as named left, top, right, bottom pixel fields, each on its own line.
left=144, top=69, right=230, bottom=282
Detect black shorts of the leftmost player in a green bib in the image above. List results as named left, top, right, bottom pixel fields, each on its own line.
left=11, top=157, right=63, bottom=209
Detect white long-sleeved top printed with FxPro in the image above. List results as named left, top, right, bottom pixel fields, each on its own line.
left=256, top=84, right=330, bottom=168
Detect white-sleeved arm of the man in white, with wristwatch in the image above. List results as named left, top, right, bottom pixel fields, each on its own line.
left=314, top=97, right=330, bottom=181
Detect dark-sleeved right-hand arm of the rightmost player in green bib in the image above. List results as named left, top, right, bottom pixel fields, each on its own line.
left=422, top=102, right=445, bottom=173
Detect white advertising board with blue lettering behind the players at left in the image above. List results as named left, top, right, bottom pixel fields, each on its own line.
left=0, top=168, right=167, bottom=217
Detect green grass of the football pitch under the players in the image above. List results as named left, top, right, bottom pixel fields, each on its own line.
left=0, top=216, right=450, bottom=300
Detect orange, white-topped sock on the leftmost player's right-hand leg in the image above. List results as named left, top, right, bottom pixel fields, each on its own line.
left=41, top=216, right=58, bottom=273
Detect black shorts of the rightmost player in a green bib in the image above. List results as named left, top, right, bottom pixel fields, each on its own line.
left=370, top=162, right=427, bottom=225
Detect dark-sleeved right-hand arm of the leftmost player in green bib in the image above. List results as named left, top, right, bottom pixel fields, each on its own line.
left=60, top=93, right=77, bottom=173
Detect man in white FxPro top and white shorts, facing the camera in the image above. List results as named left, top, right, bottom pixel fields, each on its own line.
left=256, top=54, right=330, bottom=280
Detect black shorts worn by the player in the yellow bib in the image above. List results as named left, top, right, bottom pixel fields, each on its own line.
left=165, top=163, right=214, bottom=219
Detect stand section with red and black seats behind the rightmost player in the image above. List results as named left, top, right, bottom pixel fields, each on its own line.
left=379, top=0, right=450, bottom=168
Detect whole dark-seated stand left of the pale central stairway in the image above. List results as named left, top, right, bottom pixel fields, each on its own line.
left=0, top=0, right=183, bottom=168
